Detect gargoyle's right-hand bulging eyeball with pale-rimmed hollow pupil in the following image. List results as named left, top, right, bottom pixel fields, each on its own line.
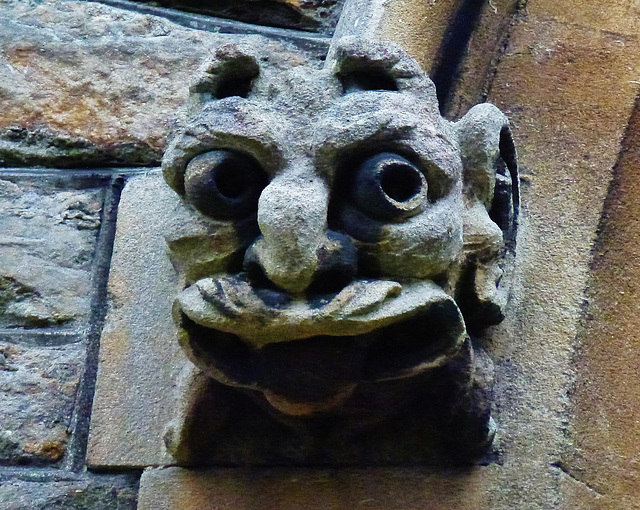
left=351, top=152, right=428, bottom=221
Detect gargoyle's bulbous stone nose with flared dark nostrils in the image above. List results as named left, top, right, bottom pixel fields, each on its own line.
left=245, top=175, right=357, bottom=295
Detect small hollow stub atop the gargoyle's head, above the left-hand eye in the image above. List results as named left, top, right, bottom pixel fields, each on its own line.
left=189, top=44, right=260, bottom=113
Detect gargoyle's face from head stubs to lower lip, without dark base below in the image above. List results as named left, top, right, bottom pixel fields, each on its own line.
left=163, top=40, right=517, bottom=415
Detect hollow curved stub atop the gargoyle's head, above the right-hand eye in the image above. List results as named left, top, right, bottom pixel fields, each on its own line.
left=328, top=36, right=437, bottom=105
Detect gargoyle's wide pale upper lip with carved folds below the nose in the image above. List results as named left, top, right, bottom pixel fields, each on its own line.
left=177, top=275, right=464, bottom=348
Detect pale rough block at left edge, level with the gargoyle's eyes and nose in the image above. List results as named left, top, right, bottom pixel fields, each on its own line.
left=0, top=178, right=104, bottom=328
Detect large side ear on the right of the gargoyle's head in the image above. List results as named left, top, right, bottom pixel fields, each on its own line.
left=455, top=103, right=520, bottom=330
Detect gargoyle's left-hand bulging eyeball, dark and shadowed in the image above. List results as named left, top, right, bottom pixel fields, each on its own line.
left=184, top=150, right=268, bottom=219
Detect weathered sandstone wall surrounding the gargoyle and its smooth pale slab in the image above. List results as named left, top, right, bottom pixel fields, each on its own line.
left=0, top=0, right=640, bottom=510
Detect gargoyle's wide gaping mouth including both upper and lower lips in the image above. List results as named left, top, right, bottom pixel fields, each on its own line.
left=174, top=277, right=466, bottom=416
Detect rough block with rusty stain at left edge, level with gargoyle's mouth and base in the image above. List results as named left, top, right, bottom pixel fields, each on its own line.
left=0, top=333, right=85, bottom=468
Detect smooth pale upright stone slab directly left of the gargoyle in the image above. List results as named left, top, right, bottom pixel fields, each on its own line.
left=88, top=170, right=187, bottom=466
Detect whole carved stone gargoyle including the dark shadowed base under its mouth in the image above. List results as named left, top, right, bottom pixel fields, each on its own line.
left=162, top=38, right=518, bottom=465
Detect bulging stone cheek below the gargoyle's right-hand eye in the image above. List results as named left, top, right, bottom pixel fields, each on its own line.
left=343, top=197, right=463, bottom=278
